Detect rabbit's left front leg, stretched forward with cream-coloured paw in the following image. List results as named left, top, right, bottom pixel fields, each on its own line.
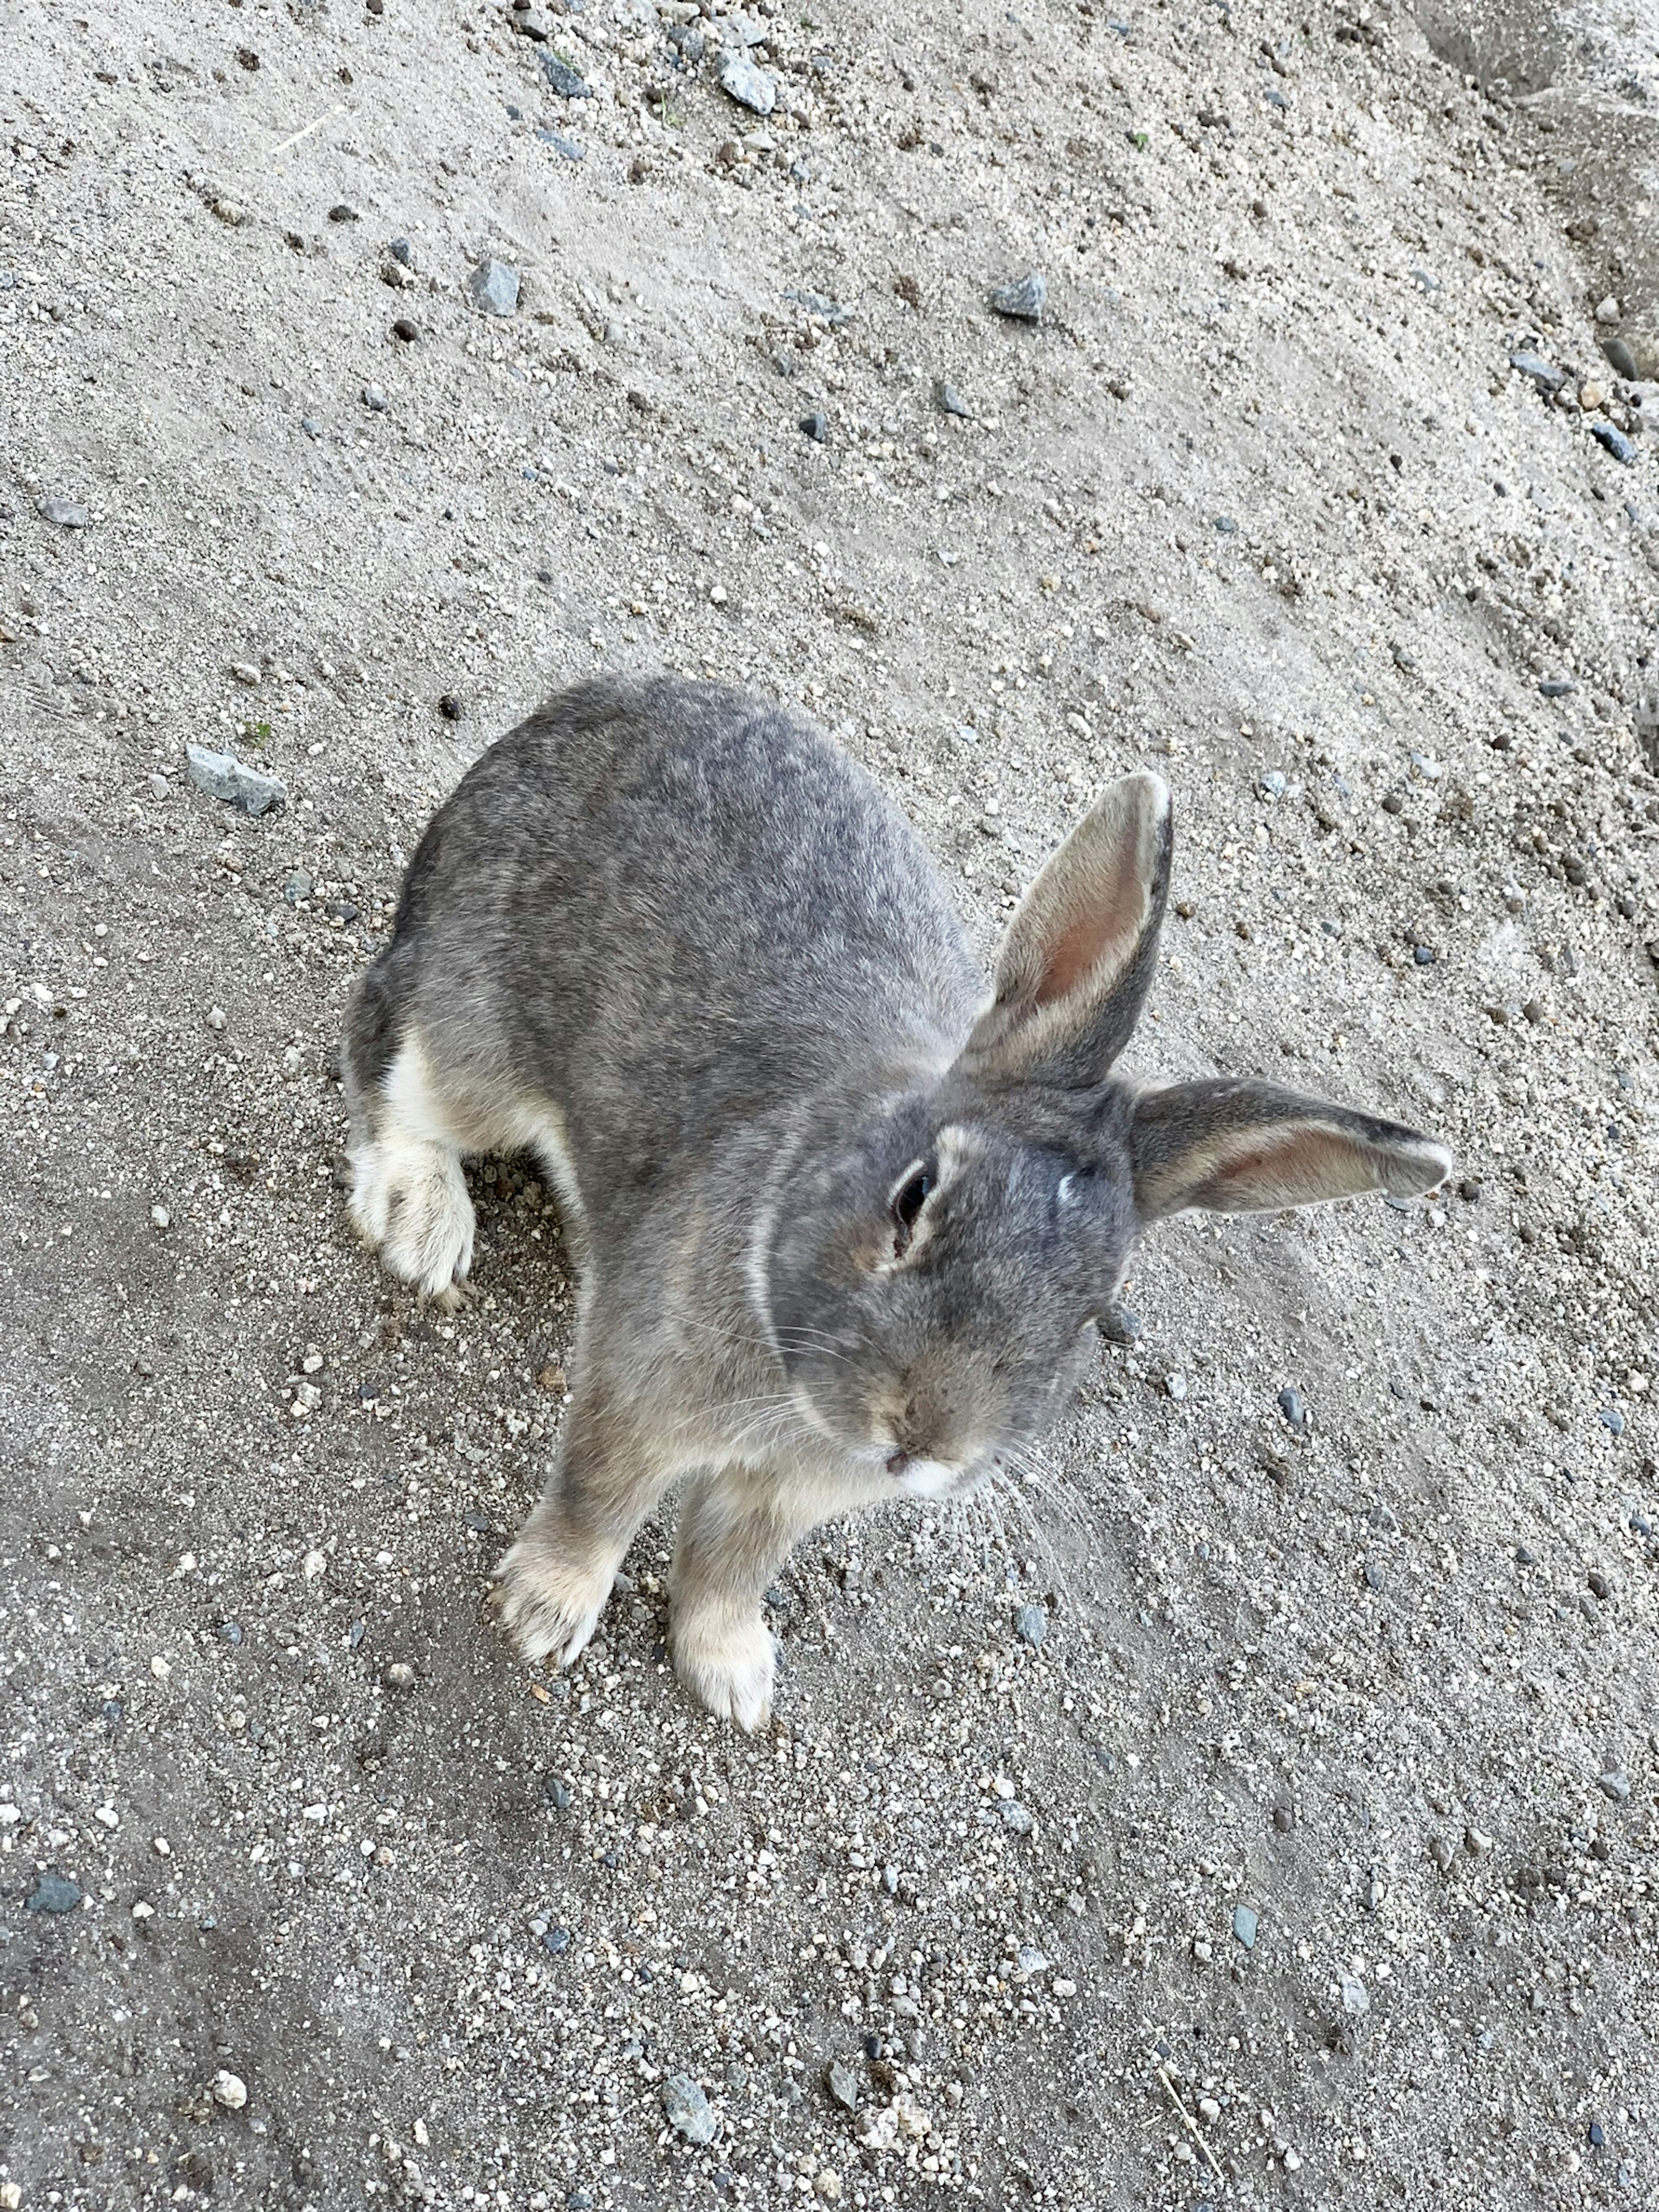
left=496, top=1380, right=675, bottom=1665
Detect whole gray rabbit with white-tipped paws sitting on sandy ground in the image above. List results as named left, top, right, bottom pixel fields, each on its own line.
left=345, top=679, right=1449, bottom=1730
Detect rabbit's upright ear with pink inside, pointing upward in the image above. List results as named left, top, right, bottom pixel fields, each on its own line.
left=962, top=774, right=1173, bottom=1088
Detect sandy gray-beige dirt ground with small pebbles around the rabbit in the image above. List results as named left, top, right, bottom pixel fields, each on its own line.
left=0, top=0, right=1659, bottom=2212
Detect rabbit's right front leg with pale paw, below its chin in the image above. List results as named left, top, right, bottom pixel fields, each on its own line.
left=668, top=1469, right=818, bottom=1734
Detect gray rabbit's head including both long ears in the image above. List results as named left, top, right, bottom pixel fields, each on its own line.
left=756, top=774, right=1451, bottom=1495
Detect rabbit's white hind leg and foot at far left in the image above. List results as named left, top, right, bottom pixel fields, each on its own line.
left=350, top=1029, right=474, bottom=1305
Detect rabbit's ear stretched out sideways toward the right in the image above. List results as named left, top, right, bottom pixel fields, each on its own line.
left=1130, top=1082, right=1451, bottom=1221
